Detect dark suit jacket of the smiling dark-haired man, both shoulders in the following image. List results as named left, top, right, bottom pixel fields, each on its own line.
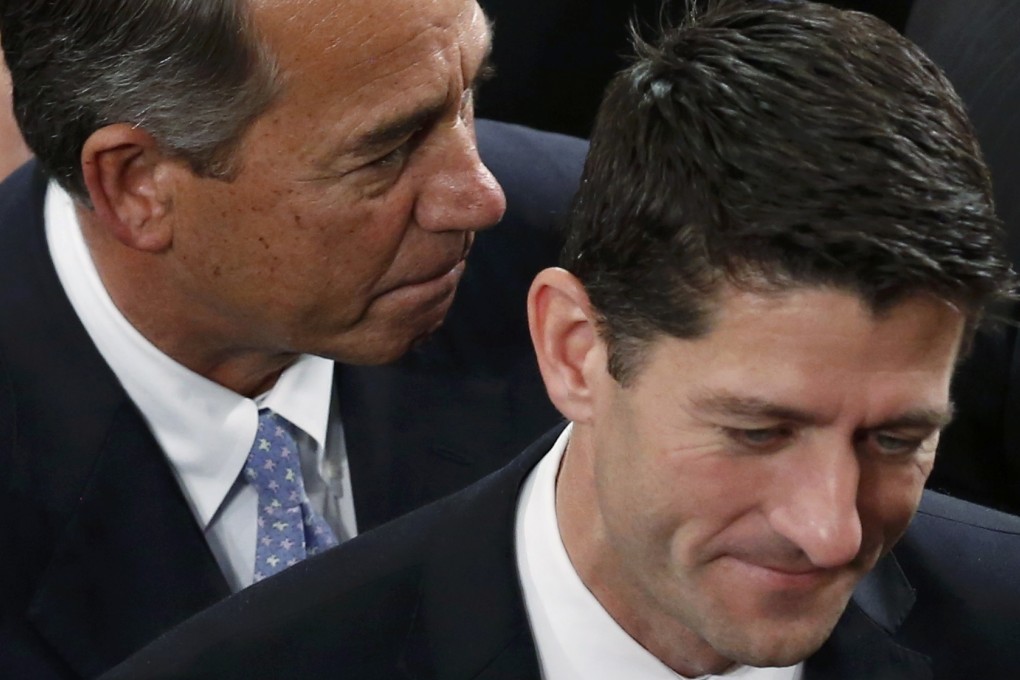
left=103, top=428, right=1020, bottom=680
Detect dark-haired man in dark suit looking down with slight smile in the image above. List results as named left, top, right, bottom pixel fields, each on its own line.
left=103, top=0, right=1020, bottom=680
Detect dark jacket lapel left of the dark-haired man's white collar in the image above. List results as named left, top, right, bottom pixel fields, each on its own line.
left=402, top=428, right=562, bottom=680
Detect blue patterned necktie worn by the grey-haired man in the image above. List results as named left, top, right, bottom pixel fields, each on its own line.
left=245, top=409, right=337, bottom=583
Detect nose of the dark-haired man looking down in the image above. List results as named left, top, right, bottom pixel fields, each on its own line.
left=768, top=446, right=862, bottom=568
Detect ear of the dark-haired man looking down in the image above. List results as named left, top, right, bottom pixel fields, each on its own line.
left=527, top=268, right=607, bottom=423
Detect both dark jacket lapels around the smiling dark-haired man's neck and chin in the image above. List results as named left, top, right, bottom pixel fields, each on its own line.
left=391, top=427, right=931, bottom=680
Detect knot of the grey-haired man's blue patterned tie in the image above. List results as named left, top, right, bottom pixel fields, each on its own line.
left=245, top=409, right=305, bottom=505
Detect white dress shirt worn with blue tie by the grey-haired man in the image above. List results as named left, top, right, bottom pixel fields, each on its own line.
left=45, top=181, right=357, bottom=591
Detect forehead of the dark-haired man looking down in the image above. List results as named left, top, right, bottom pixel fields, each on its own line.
left=620, top=286, right=963, bottom=420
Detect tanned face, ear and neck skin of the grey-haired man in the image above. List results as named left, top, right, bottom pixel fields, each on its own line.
left=71, top=0, right=505, bottom=396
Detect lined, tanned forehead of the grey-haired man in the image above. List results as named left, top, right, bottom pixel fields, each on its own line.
left=239, top=0, right=491, bottom=169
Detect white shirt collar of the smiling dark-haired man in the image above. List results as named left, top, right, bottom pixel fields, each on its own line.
left=516, top=426, right=803, bottom=680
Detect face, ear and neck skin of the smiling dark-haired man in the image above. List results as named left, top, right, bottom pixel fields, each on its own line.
left=528, top=269, right=964, bottom=676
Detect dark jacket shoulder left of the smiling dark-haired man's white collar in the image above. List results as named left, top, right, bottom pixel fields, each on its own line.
left=102, top=428, right=560, bottom=680
